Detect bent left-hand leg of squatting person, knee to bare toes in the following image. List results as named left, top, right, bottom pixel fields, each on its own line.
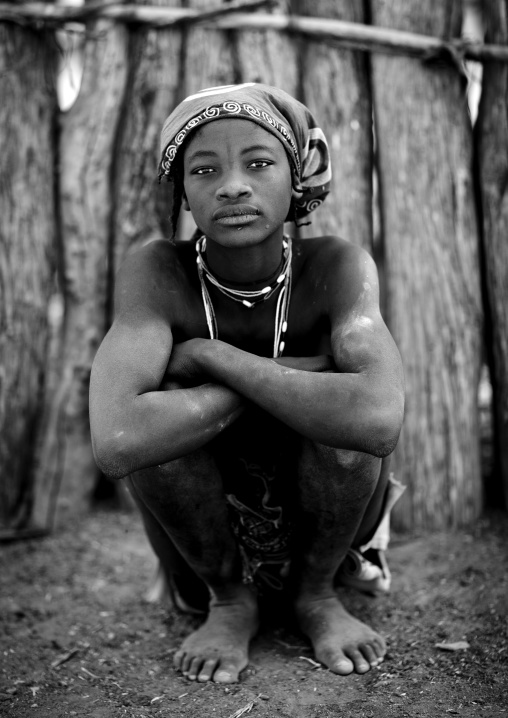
left=130, top=450, right=258, bottom=683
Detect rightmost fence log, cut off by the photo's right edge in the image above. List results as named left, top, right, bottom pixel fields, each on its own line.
left=476, top=0, right=508, bottom=506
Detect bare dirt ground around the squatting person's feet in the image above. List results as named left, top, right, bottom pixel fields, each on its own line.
left=0, top=509, right=508, bottom=718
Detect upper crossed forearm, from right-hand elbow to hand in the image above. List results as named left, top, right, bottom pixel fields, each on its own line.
left=198, top=340, right=403, bottom=455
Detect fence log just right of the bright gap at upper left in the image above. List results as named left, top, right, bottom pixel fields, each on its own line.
left=32, top=8, right=127, bottom=521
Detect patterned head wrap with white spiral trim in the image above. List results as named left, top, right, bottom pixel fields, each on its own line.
left=159, top=82, right=332, bottom=219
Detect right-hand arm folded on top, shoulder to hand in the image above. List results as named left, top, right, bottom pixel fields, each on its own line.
left=168, top=248, right=404, bottom=457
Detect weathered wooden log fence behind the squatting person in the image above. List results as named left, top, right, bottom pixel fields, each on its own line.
left=0, top=0, right=508, bottom=535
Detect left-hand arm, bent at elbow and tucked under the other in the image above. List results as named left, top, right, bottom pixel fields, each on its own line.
left=90, top=247, right=246, bottom=478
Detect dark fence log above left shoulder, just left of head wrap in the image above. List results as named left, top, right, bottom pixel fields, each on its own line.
left=112, top=0, right=182, bottom=275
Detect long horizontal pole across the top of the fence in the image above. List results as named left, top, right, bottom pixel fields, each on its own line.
left=0, top=0, right=508, bottom=62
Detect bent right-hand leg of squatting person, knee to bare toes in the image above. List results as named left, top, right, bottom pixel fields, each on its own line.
left=292, top=440, right=386, bottom=675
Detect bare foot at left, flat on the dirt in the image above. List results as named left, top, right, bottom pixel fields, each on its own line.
left=174, top=596, right=259, bottom=683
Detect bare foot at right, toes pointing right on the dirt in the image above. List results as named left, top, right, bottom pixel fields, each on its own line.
left=296, top=595, right=386, bottom=676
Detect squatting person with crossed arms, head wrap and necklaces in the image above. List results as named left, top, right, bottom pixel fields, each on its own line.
left=90, top=83, right=404, bottom=683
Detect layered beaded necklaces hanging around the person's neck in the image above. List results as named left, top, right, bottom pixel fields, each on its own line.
left=196, top=235, right=292, bottom=358
